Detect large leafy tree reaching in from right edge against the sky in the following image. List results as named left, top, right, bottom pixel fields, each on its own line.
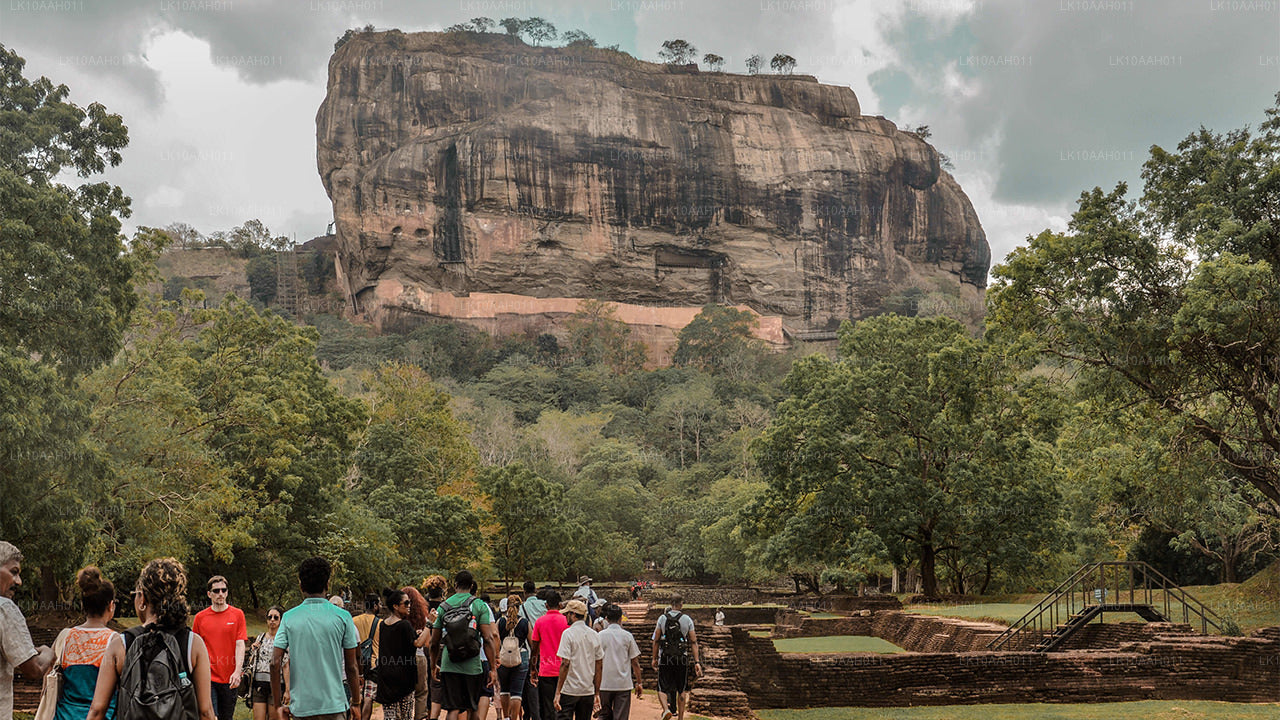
left=988, top=95, right=1280, bottom=518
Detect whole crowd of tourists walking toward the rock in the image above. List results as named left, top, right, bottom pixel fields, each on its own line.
left=0, top=541, right=703, bottom=720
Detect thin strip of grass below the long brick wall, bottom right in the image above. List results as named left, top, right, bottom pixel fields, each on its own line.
left=759, top=700, right=1280, bottom=720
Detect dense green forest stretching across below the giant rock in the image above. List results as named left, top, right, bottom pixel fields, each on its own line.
left=0, top=40, right=1280, bottom=606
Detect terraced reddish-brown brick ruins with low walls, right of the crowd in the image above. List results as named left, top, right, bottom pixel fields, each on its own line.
left=616, top=606, right=1280, bottom=717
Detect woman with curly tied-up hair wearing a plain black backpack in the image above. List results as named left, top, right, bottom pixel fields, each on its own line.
left=87, top=557, right=216, bottom=720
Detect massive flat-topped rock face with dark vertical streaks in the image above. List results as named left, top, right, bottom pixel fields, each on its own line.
left=316, top=31, right=989, bottom=351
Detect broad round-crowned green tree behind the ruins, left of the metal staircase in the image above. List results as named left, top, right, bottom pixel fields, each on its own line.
left=755, top=315, right=1060, bottom=596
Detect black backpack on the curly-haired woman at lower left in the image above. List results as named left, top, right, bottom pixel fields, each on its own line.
left=115, top=625, right=200, bottom=720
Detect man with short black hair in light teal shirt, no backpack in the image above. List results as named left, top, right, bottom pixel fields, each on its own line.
left=271, top=557, right=364, bottom=720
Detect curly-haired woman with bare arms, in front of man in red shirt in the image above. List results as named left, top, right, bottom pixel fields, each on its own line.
left=88, top=557, right=214, bottom=720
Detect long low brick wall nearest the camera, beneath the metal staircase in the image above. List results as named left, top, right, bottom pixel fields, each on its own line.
left=732, top=628, right=1280, bottom=708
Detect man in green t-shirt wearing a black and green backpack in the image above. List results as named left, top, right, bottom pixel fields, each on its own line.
left=431, top=570, right=498, bottom=720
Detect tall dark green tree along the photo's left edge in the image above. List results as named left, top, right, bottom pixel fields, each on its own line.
left=0, top=41, right=152, bottom=600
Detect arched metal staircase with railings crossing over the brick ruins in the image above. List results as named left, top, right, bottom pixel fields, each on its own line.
left=987, top=561, right=1222, bottom=652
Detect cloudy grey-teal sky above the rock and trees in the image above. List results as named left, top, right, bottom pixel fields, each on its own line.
left=0, top=0, right=1280, bottom=263
